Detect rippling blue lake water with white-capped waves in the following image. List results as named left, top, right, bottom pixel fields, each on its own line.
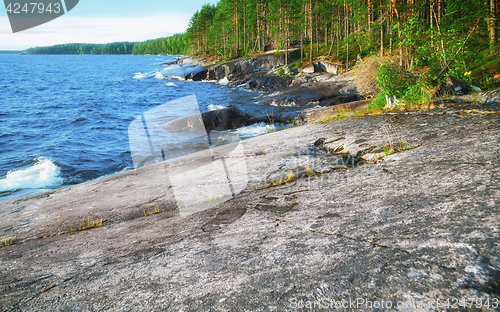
left=0, top=54, right=286, bottom=200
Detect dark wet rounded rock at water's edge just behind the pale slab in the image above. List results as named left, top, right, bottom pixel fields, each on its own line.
left=202, top=107, right=253, bottom=131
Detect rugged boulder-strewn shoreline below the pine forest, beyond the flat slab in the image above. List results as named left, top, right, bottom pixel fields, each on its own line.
left=169, top=50, right=500, bottom=130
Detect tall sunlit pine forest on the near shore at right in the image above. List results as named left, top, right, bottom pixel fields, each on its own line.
left=186, top=0, right=499, bottom=77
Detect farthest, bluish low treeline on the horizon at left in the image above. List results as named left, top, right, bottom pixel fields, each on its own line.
left=24, top=42, right=135, bottom=54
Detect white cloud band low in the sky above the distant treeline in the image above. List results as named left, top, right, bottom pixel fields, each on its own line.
left=0, top=13, right=191, bottom=50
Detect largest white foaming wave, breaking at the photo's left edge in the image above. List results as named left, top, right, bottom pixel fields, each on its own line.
left=0, top=158, right=63, bottom=192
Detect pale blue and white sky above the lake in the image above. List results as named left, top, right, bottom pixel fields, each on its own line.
left=0, top=0, right=217, bottom=50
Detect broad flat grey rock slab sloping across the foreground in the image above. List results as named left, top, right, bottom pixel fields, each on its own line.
left=0, top=103, right=500, bottom=311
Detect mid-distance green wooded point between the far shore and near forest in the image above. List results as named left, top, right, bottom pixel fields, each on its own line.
left=132, top=34, right=191, bottom=55
